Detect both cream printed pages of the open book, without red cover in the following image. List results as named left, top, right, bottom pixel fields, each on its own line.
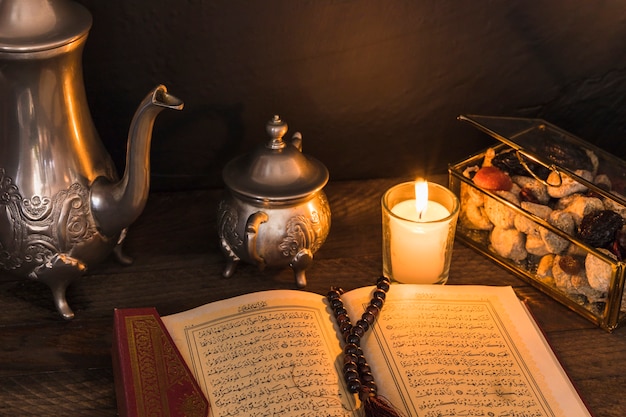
left=113, top=284, right=591, bottom=417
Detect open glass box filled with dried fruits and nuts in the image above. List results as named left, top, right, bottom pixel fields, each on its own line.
left=449, top=116, right=626, bottom=331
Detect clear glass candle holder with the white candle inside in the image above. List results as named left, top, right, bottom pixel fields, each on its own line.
left=381, top=182, right=460, bottom=284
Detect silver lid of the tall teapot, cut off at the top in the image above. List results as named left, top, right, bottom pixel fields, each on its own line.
left=0, top=0, right=92, bottom=53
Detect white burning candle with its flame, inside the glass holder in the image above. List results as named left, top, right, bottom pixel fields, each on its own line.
left=389, top=180, right=451, bottom=284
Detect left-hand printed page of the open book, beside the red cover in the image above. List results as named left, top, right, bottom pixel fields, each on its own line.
left=162, top=290, right=357, bottom=417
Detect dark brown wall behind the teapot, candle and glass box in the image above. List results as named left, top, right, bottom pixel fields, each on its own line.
left=75, top=0, right=626, bottom=190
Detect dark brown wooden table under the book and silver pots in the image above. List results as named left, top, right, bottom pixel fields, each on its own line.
left=0, top=177, right=626, bottom=417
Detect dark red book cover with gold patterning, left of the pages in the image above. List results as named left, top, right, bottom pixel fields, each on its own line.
left=112, top=307, right=209, bottom=417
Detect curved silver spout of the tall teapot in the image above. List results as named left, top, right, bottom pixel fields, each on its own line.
left=90, top=85, right=184, bottom=236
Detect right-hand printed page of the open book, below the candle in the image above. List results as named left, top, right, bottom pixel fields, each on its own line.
left=344, top=284, right=590, bottom=417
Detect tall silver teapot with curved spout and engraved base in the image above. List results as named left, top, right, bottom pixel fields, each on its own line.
left=0, top=0, right=183, bottom=319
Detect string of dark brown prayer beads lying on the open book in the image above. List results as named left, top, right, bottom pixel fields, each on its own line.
left=326, top=277, right=391, bottom=400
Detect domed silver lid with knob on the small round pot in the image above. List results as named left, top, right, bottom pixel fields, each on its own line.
left=222, top=116, right=329, bottom=201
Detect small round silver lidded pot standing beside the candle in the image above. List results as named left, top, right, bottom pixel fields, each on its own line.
left=217, top=116, right=331, bottom=288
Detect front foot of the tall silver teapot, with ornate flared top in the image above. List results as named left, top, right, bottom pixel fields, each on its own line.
left=29, top=254, right=87, bottom=320
